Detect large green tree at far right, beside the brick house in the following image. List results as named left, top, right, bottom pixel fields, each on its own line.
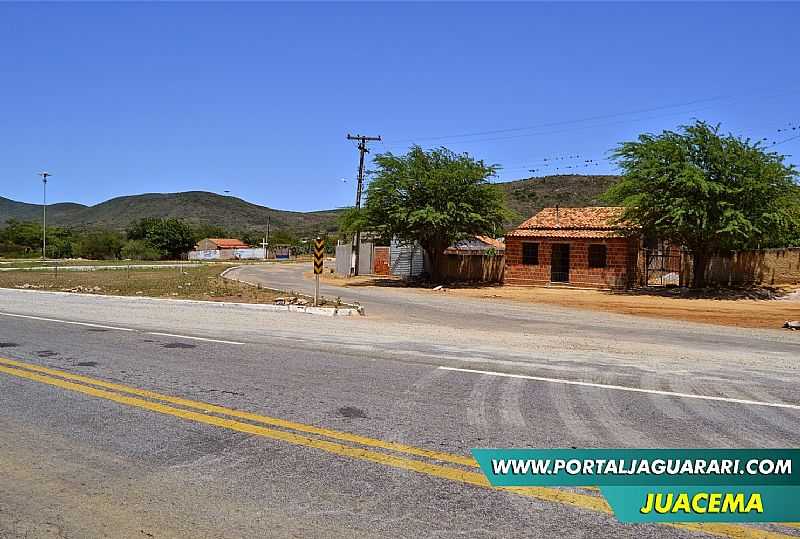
left=606, top=121, right=799, bottom=288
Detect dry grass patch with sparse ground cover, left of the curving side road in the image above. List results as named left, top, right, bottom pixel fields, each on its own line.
left=0, top=264, right=282, bottom=303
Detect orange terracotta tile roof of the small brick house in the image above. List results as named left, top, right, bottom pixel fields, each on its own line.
left=508, top=207, right=635, bottom=238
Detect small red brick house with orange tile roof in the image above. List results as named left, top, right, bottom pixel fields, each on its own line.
left=504, top=206, right=640, bottom=288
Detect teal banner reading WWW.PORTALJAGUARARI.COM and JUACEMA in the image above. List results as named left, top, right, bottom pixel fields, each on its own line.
left=472, top=449, right=800, bottom=522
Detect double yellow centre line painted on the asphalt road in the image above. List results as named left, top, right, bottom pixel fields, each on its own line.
left=0, top=358, right=788, bottom=539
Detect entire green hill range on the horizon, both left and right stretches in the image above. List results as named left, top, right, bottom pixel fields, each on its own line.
left=0, top=175, right=619, bottom=235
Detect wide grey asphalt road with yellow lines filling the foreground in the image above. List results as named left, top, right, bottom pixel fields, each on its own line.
left=0, top=284, right=800, bottom=537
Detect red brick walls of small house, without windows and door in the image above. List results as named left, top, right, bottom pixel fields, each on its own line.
left=503, top=236, right=638, bottom=288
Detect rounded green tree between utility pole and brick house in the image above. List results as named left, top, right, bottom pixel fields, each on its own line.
left=350, top=146, right=509, bottom=280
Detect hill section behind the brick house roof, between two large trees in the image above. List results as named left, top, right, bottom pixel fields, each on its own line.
left=496, top=174, right=620, bottom=226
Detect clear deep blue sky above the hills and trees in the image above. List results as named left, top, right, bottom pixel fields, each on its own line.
left=0, top=3, right=800, bottom=210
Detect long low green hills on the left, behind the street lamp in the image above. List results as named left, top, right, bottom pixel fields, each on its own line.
left=0, top=191, right=341, bottom=235
